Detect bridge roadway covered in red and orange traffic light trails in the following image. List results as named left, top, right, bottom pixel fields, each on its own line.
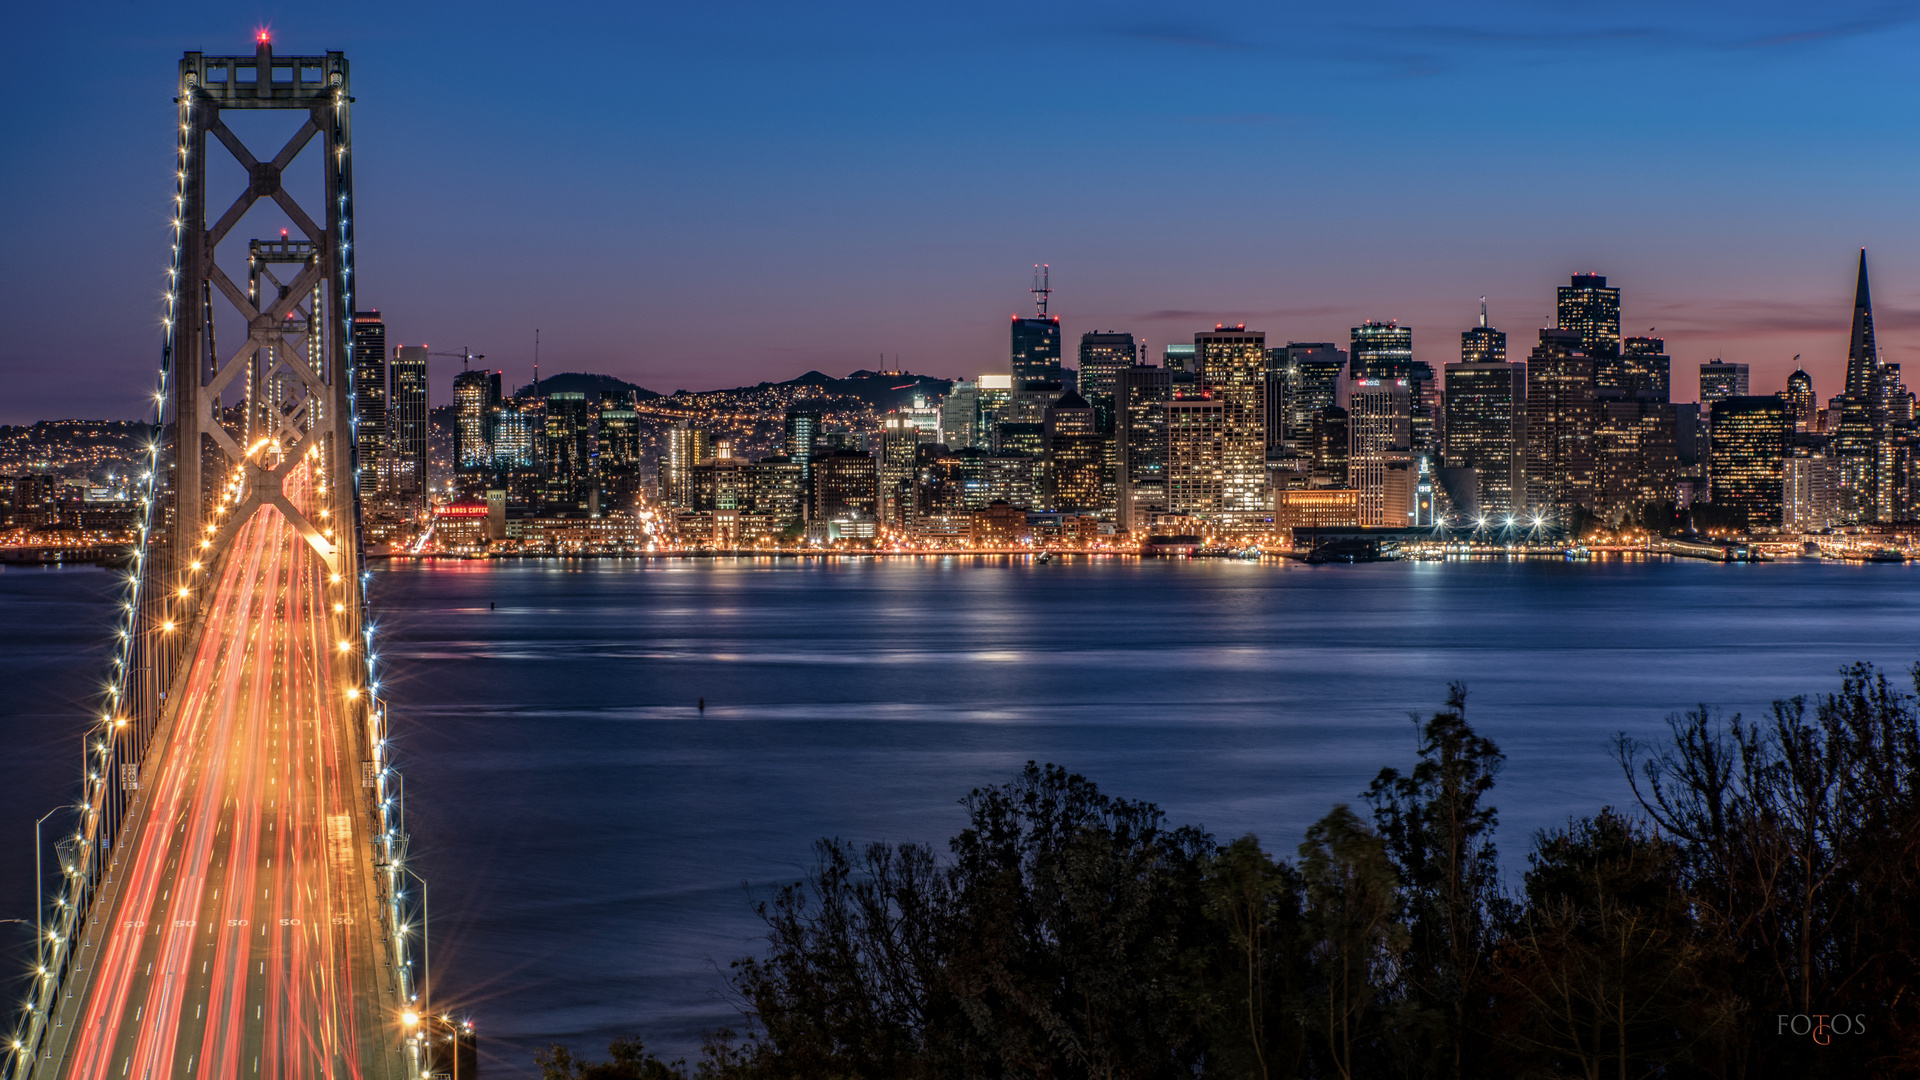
left=44, top=469, right=403, bottom=1080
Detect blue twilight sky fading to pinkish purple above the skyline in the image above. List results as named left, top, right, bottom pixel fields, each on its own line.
left=0, top=0, right=1920, bottom=423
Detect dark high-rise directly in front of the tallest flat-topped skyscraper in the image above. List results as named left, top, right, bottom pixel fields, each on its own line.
left=1526, top=329, right=1596, bottom=525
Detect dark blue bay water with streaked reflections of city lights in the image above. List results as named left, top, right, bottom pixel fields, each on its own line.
left=0, top=557, right=1920, bottom=1076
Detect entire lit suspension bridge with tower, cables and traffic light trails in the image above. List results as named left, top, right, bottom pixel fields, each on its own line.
left=6, top=33, right=445, bottom=1080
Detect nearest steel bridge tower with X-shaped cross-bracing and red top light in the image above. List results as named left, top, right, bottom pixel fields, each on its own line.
left=165, top=33, right=359, bottom=625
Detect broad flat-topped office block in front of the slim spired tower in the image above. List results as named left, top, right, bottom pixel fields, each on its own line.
left=1444, top=357, right=1526, bottom=517
